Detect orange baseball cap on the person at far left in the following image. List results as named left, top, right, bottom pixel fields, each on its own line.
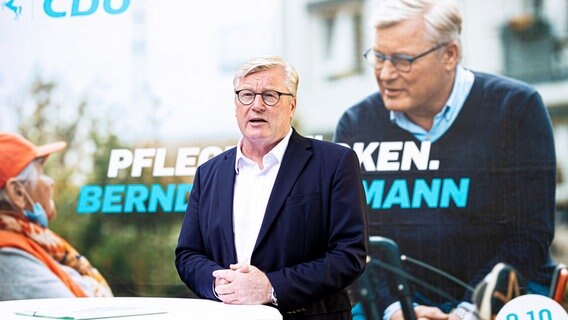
left=0, top=132, right=67, bottom=189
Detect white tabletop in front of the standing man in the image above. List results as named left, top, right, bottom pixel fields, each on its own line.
left=0, top=297, right=282, bottom=320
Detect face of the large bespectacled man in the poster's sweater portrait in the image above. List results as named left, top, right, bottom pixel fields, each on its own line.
left=373, top=17, right=457, bottom=124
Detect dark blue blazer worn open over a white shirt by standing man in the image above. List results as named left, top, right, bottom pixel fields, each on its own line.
left=176, top=131, right=367, bottom=315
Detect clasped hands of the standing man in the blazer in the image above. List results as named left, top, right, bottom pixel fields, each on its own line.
left=213, top=263, right=272, bottom=304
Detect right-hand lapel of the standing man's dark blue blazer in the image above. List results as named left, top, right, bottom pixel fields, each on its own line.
left=255, top=130, right=312, bottom=249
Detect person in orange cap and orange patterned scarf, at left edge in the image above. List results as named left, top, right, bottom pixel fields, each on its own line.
left=0, top=132, right=112, bottom=300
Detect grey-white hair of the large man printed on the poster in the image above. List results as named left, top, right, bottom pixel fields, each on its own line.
left=371, top=0, right=462, bottom=52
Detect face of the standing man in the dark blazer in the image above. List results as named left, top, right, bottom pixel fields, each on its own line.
left=235, top=67, right=296, bottom=149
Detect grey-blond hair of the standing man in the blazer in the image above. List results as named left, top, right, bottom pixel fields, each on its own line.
left=233, top=56, right=300, bottom=96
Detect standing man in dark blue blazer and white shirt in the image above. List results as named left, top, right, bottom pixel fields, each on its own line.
left=176, top=56, right=367, bottom=319
